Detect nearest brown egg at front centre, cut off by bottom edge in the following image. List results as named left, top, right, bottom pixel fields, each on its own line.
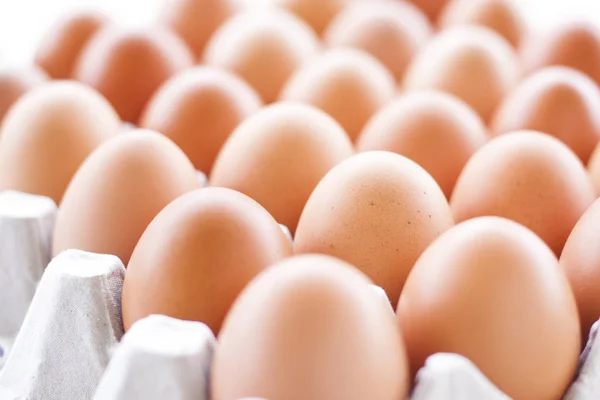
left=211, top=255, right=410, bottom=400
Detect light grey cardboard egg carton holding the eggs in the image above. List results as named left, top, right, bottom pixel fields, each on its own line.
left=0, top=192, right=600, bottom=400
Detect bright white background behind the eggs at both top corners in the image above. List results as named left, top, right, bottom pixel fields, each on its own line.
left=0, top=0, right=600, bottom=65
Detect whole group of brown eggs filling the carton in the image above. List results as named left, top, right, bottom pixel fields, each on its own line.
left=0, top=0, right=600, bottom=399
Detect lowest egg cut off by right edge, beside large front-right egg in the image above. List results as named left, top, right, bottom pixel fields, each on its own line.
left=560, top=200, right=600, bottom=345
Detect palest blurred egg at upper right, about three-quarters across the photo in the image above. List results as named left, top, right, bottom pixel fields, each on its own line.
left=404, top=26, right=519, bottom=122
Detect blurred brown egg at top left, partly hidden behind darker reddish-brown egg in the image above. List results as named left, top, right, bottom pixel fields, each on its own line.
left=35, top=11, right=108, bottom=79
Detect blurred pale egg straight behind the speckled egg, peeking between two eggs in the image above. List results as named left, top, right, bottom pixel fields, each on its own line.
left=281, top=49, right=395, bottom=140
